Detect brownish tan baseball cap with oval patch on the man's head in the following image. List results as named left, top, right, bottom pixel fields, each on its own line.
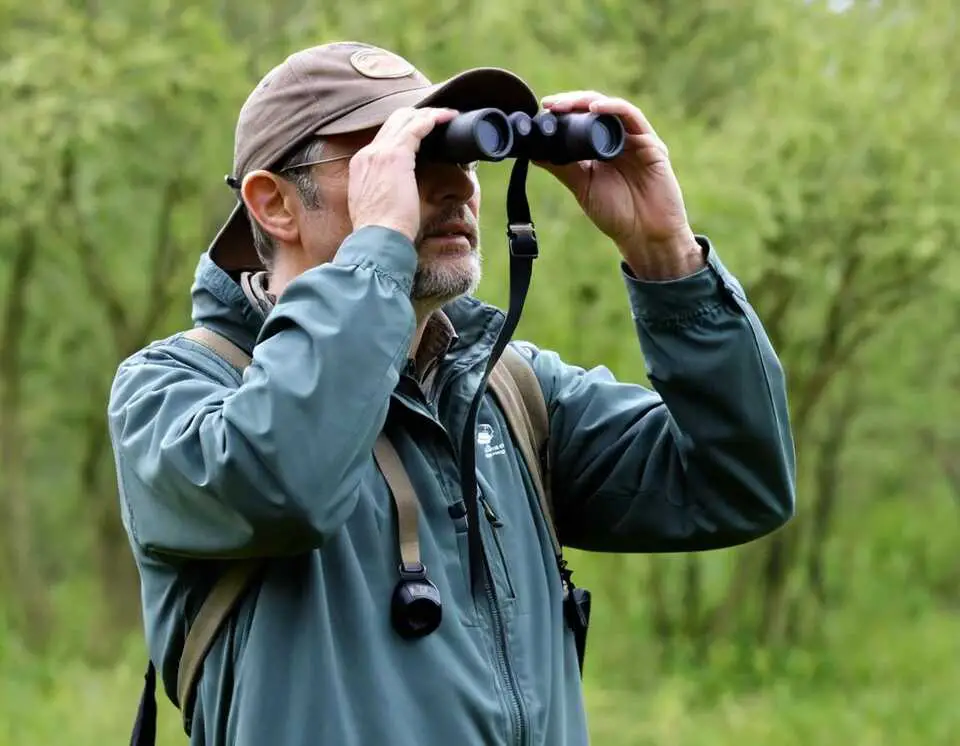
left=209, top=41, right=539, bottom=272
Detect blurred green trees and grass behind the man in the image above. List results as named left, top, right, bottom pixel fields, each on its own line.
left=0, top=0, right=960, bottom=746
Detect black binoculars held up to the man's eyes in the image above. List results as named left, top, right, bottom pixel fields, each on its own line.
left=419, top=108, right=626, bottom=165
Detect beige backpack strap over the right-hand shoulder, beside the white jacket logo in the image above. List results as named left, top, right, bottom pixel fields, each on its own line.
left=488, top=345, right=560, bottom=557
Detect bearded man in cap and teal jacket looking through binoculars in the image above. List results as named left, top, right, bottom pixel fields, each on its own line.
left=109, top=43, right=794, bottom=746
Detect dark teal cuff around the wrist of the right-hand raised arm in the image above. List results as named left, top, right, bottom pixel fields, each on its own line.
left=620, top=236, right=746, bottom=322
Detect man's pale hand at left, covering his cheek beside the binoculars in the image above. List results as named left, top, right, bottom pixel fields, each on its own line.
left=347, top=108, right=457, bottom=241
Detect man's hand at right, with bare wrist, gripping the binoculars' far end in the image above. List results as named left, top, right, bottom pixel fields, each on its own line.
left=537, top=91, right=704, bottom=280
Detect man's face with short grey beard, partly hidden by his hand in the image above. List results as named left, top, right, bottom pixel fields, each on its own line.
left=297, top=125, right=481, bottom=305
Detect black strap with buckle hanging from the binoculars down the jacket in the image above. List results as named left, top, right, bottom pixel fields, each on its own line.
left=460, top=158, right=539, bottom=593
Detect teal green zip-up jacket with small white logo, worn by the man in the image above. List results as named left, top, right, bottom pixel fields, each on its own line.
left=109, top=227, right=795, bottom=746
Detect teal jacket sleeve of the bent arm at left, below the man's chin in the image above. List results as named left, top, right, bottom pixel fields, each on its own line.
left=108, top=227, right=417, bottom=558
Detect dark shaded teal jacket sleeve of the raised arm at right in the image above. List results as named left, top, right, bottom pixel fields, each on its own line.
left=530, top=237, right=795, bottom=552
